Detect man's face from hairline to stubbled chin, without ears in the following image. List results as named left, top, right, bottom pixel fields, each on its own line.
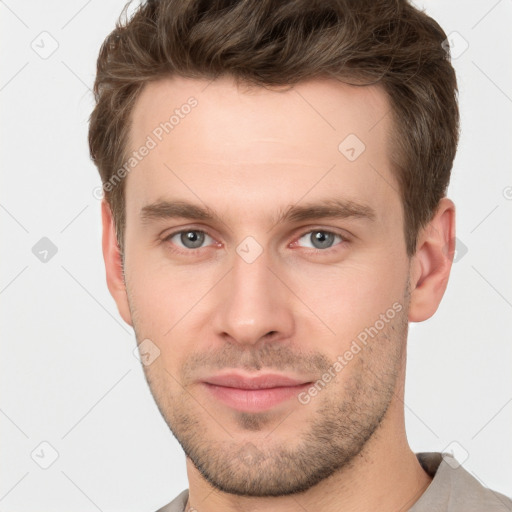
left=116, top=78, right=409, bottom=496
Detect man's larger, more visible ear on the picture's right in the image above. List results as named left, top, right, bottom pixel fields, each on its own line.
left=409, top=197, right=455, bottom=322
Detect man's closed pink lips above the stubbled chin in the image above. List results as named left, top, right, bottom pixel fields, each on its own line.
left=201, top=373, right=311, bottom=412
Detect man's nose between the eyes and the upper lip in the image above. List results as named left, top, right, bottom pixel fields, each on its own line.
left=210, top=245, right=294, bottom=345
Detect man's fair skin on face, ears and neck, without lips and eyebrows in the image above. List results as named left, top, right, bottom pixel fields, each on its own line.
left=102, top=73, right=455, bottom=512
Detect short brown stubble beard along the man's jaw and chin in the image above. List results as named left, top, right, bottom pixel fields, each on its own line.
left=134, top=300, right=408, bottom=497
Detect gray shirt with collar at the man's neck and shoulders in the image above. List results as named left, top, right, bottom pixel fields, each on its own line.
left=157, top=452, right=512, bottom=512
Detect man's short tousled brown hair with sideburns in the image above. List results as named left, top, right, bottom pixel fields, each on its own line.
left=89, top=0, right=459, bottom=256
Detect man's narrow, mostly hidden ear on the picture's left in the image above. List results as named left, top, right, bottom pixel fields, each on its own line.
left=101, top=199, right=133, bottom=325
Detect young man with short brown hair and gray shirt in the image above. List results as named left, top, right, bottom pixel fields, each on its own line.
left=89, top=0, right=512, bottom=512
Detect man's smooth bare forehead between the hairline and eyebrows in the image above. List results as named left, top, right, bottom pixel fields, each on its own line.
left=126, top=77, right=398, bottom=227
